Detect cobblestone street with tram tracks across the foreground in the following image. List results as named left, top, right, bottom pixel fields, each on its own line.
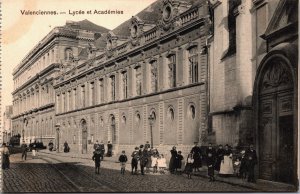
left=3, top=152, right=253, bottom=192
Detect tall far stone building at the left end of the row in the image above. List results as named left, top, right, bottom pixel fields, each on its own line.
left=12, top=20, right=108, bottom=143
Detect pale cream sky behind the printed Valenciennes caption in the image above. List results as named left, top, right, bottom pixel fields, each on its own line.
left=0, top=0, right=155, bottom=120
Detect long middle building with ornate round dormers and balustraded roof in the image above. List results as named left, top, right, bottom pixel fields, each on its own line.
left=54, top=1, right=208, bottom=155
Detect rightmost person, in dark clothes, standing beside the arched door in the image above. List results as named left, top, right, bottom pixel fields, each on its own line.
left=245, top=144, right=256, bottom=183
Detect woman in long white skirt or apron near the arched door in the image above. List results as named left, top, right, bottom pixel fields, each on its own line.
left=219, top=144, right=234, bottom=175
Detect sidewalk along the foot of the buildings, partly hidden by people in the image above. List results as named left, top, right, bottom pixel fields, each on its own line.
left=39, top=150, right=297, bottom=192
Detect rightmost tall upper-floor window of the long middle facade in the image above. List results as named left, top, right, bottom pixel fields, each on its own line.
left=189, top=46, right=198, bottom=83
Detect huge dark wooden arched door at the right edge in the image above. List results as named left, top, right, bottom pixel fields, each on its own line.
left=254, top=54, right=297, bottom=183
